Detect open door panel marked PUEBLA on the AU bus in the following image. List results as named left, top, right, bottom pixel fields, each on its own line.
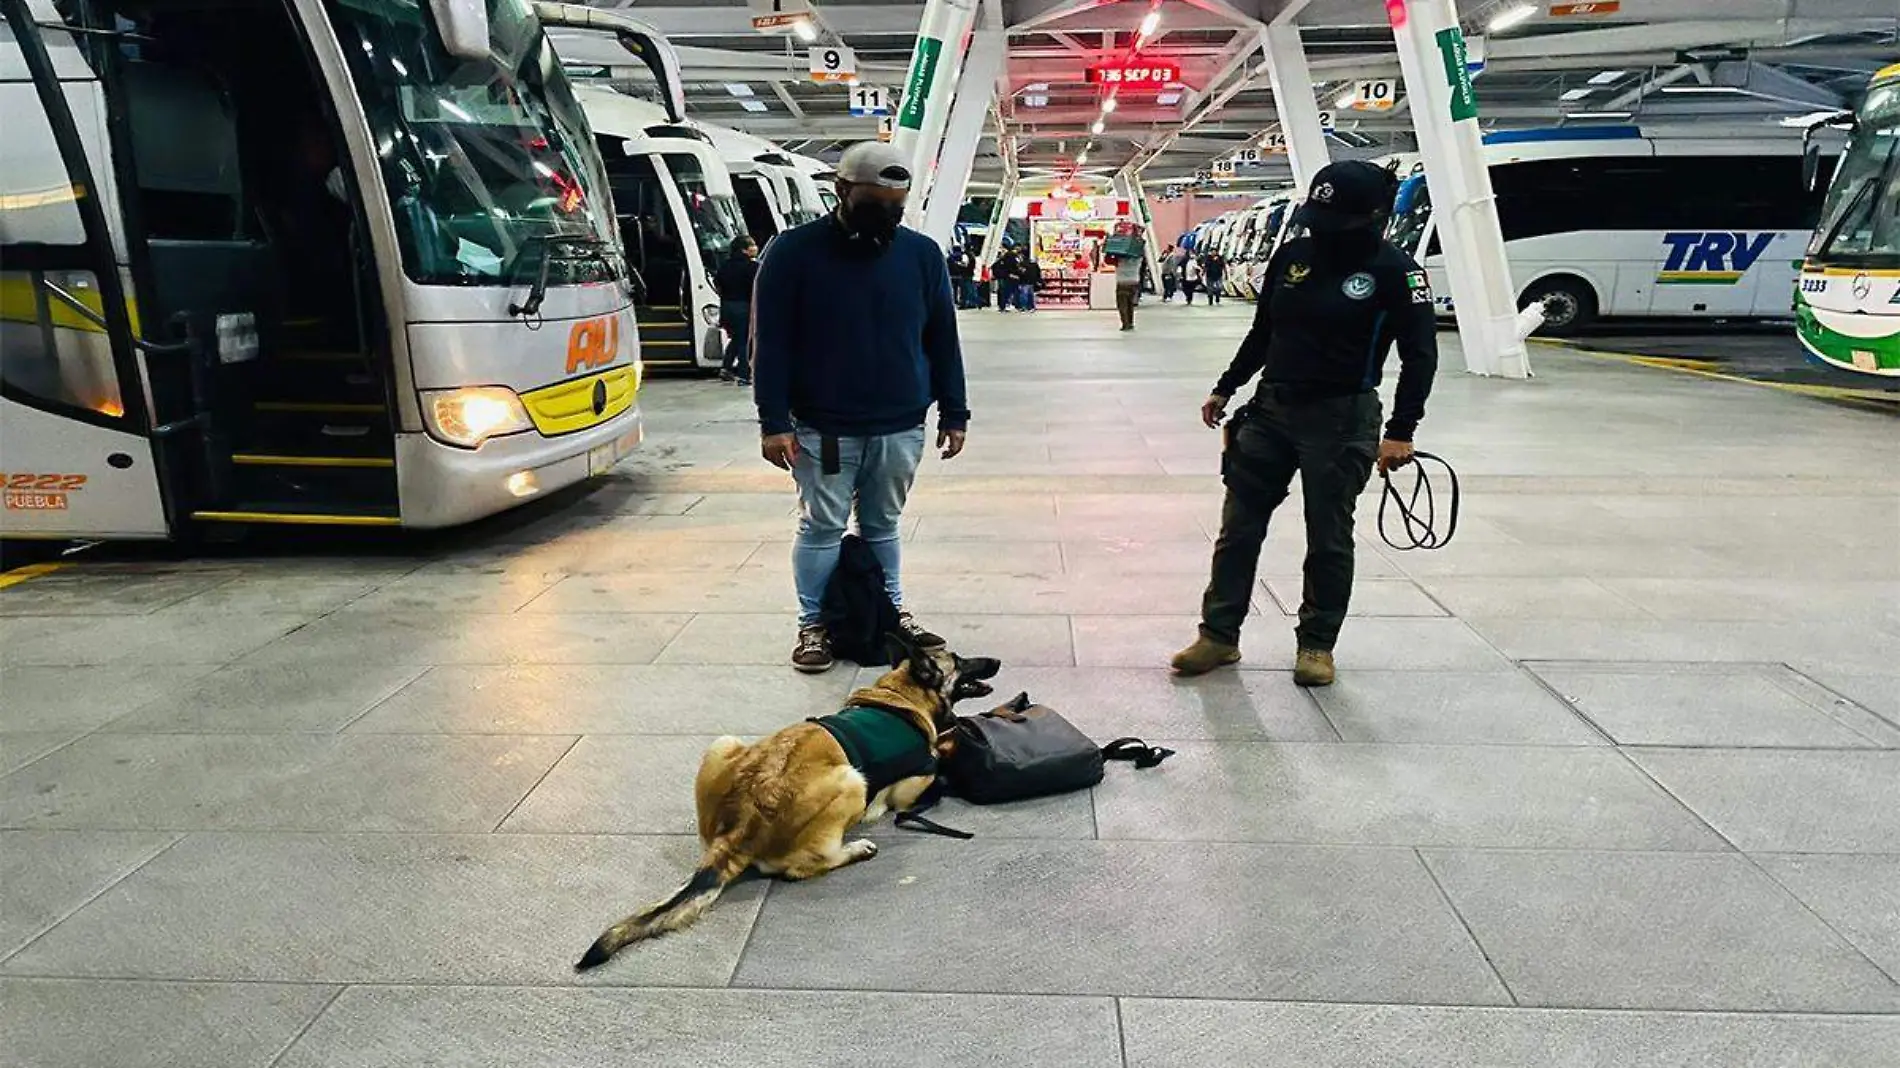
left=0, top=0, right=171, bottom=538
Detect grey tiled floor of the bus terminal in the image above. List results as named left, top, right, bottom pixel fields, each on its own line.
left=0, top=308, right=1900, bottom=1068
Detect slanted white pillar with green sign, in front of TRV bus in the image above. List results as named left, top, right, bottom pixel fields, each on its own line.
left=1389, top=0, right=1530, bottom=378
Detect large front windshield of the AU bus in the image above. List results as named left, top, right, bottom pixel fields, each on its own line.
left=329, top=0, right=623, bottom=285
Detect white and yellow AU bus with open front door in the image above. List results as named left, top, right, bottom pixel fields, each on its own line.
left=0, top=0, right=682, bottom=538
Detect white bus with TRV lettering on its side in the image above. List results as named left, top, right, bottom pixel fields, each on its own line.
left=1391, top=125, right=1820, bottom=334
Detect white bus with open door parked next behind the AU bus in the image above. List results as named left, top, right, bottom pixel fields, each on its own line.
left=576, top=87, right=745, bottom=371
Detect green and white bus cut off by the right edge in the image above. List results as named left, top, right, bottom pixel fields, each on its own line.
left=1796, top=65, right=1900, bottom=376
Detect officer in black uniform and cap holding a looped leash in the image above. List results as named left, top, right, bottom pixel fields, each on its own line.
left=1174, top=162, right=1438, bottom=686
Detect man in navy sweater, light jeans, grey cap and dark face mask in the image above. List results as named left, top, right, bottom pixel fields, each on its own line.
left=752, top=141, right=969, bottom=675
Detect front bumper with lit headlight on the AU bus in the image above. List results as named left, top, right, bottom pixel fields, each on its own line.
left=395, top=403, right=646, bottom=528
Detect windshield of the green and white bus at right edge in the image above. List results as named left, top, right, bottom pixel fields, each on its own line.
left=1809, top=80, right=1900, bottom=266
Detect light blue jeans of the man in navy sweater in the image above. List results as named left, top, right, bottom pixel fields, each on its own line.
left=792, top=426, right=923, bottom=627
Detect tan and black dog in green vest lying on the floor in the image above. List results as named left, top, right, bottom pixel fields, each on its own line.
left=574, top=635, right=1003, bottom=971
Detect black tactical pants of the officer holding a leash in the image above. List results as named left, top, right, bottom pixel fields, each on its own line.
left=1201, top=386, right=1381, bottom=652
